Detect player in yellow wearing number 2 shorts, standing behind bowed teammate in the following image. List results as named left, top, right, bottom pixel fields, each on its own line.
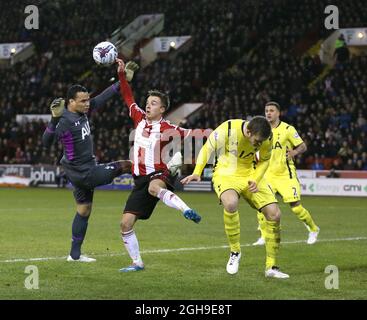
left=253, top=101, right=320, bottom=245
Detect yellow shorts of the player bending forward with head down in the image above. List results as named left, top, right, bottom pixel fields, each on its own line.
left=213, top=176, right=278, bottom=210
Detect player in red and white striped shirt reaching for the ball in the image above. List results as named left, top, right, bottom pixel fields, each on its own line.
left=116, top=59, right=201, bottom=272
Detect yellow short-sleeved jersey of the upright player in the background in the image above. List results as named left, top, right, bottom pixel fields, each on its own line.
left=266, top=121, right=303, bottom=178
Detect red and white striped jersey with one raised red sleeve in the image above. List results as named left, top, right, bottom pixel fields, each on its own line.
left=119, top=69, right=191, bottom=176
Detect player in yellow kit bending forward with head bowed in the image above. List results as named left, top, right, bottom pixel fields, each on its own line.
left=181, top=116, right=289, bottom=278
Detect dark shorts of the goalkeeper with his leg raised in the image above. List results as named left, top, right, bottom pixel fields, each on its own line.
left=65, top=161, right=131, bottom=204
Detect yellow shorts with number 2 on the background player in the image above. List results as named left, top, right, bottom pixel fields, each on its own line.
left=266, top=176, right=301, bottom=203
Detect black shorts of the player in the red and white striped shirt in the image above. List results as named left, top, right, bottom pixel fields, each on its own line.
left=124, top=171, right=175, bottom=220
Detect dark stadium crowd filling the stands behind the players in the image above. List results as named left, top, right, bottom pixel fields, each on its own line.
left=0, top=0, right=367, bottom=170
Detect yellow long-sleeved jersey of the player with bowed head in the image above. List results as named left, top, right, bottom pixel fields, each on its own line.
left=194, top=119, right=272, bottom=177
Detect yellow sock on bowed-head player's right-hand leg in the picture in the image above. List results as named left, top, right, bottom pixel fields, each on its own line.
left=265, top=220, right=280, bottom=270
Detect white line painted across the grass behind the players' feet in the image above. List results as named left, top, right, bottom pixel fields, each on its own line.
left=0, top=237, right=367, bottom=263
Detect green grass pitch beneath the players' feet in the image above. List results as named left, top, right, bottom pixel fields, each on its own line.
left=0, top=189, right=367, bottom=300
